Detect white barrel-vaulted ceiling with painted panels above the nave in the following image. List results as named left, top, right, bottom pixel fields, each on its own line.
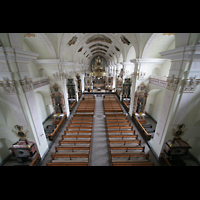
left=23, top=33, right=175, bottom=64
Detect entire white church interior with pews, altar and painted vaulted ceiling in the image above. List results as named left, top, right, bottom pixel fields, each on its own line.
left=0, top=33, right=200, bottom=166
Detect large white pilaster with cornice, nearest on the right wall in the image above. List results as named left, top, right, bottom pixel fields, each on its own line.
left=152, top=45, right=200, bottom=156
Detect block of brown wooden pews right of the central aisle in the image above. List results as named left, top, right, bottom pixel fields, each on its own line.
left=104, top=95, right=154, bottom=166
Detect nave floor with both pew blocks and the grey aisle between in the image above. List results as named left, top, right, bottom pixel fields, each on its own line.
left=41, top=94, right=159, bottom=166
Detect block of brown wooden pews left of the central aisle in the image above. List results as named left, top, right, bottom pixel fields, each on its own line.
left=46, top=97, right=95, bottom=166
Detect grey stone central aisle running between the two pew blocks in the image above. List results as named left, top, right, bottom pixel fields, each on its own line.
left=90, top=97, right=110, bottom=166
